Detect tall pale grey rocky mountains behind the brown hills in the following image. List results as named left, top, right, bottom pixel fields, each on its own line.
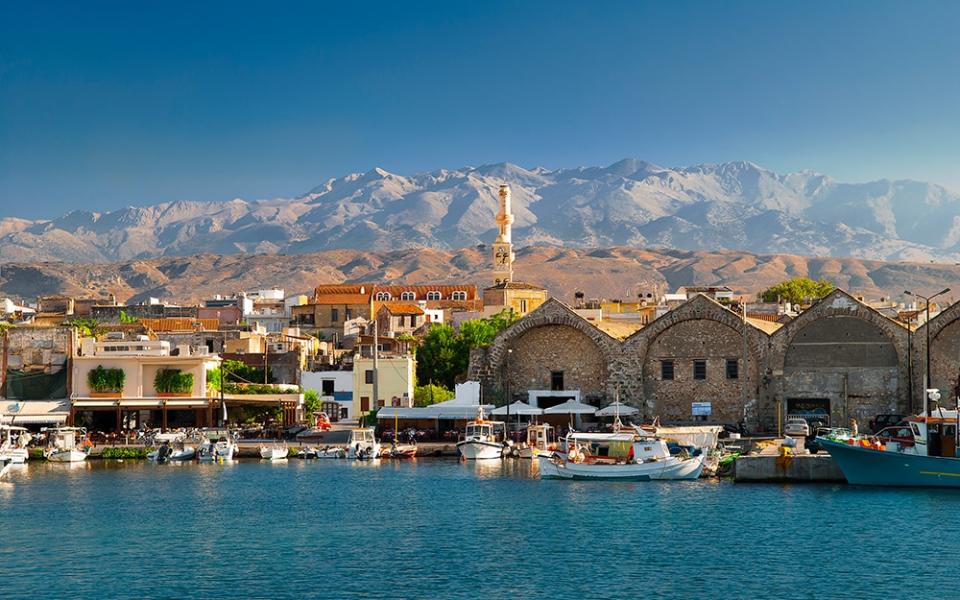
left=0, top=159, right=960, bottom=262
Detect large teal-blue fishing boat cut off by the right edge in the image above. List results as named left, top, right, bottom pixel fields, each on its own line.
left=817, top=408, right=960, bottom=488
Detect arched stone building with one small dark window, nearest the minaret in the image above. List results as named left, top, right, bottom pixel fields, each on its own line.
left=469, top=298, right=619, bottom=408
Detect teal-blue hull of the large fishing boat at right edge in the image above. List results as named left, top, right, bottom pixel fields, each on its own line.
left=817, top=438, right=960, bottom=488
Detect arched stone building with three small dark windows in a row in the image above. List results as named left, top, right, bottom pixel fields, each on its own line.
left=613, top=295, right=767, bottom=426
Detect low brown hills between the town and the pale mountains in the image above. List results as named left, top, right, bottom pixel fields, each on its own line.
left=0, top=246, right=960, bottom=303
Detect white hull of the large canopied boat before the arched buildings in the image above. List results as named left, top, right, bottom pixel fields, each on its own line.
left=537, top=455, right=704, bottom=481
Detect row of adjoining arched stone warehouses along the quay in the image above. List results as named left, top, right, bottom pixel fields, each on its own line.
left=469, top=290, right=936, bottom=431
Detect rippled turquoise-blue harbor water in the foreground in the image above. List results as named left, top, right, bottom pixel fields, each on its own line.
left=0, top=460, right=960, bottom=599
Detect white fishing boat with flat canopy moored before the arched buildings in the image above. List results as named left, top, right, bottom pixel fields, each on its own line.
left=537, top=431, right=707, bottom=481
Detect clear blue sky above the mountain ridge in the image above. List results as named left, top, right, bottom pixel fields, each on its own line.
left=0, top=1, right=960, bottom=217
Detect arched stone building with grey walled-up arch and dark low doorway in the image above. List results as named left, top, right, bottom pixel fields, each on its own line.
left=760, top=290, right=909, bottom=430
